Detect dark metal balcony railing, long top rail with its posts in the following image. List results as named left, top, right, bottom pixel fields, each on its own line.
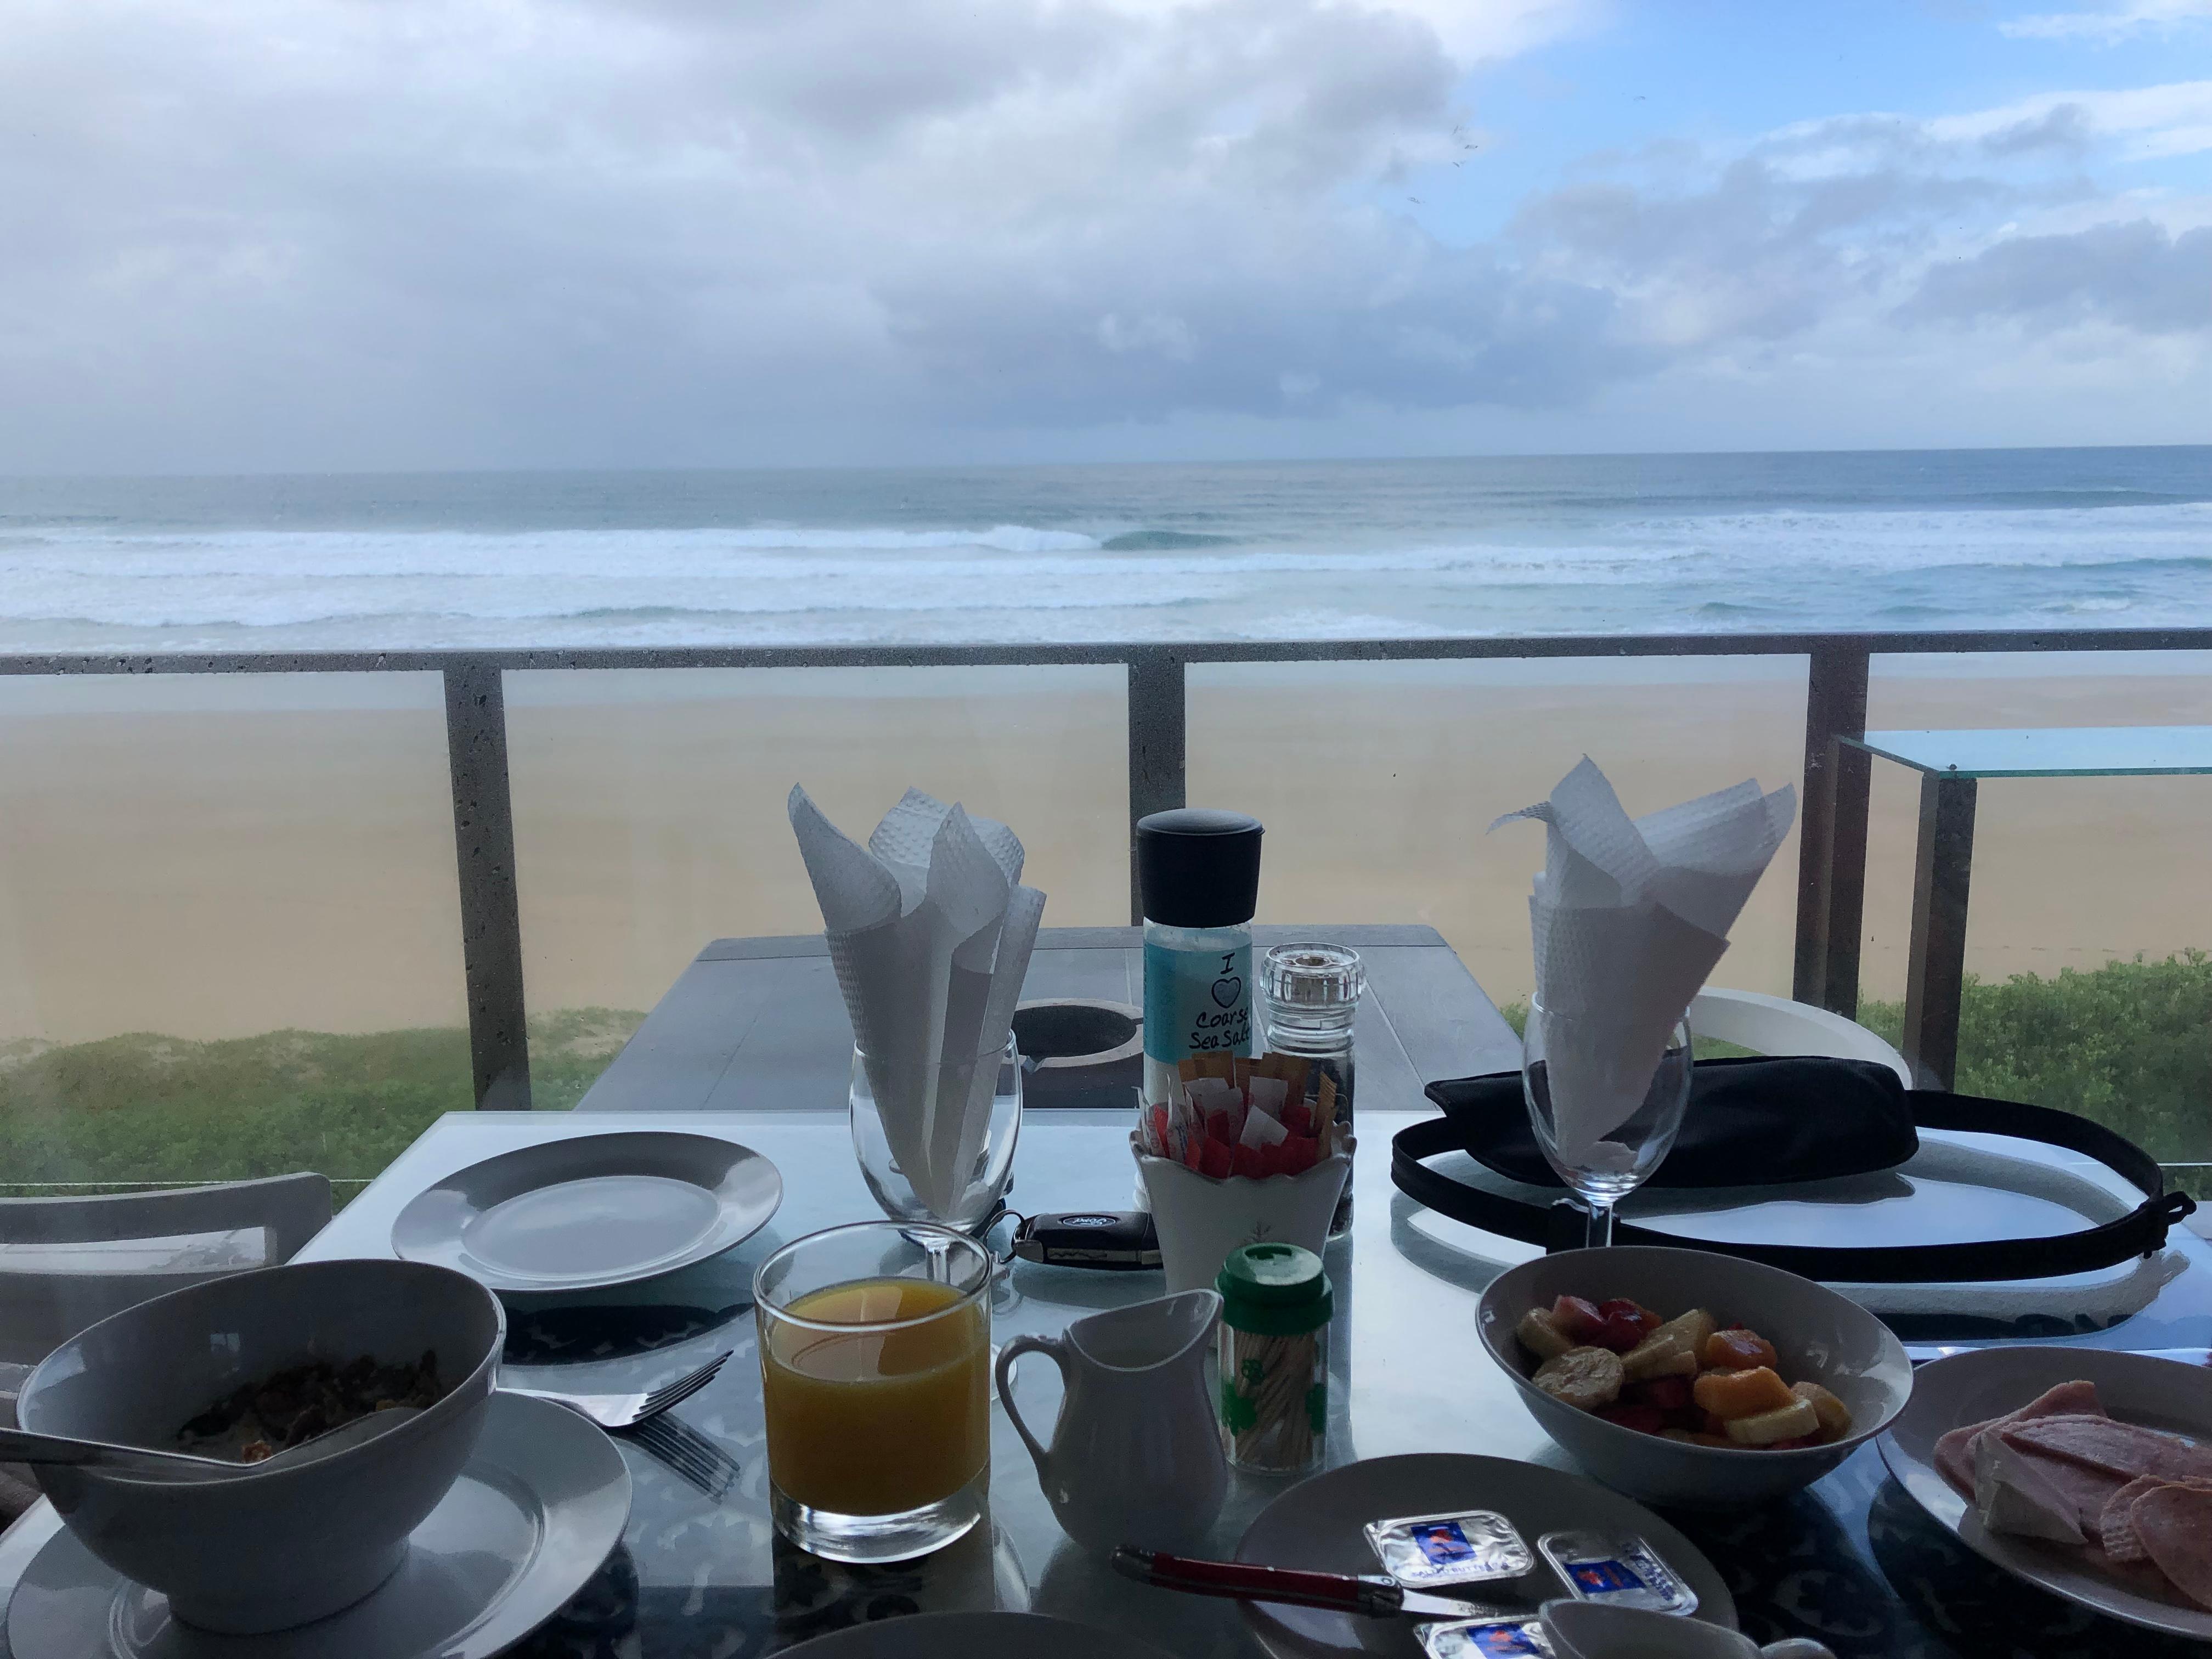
left=0, top=628, right=2212, bottom=1108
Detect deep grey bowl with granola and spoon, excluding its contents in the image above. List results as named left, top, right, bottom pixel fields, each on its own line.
left=15, top=1261, right=506, bottom=1635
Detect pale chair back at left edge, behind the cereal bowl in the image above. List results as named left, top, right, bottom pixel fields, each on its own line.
left=0, top=1172, right=330, bottom=1393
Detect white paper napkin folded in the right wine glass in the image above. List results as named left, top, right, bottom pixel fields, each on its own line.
left=1491, top=757, right=1796, bottom=1168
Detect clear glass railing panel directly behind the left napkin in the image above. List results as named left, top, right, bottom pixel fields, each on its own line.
left=506, top=666, right=1128, bottom=1106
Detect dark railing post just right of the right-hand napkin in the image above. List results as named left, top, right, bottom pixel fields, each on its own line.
left=1790, top=641, right=1869, bottom=1018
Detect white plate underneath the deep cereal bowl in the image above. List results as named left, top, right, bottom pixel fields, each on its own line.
left=7, top=1393, right=630, bottom=1659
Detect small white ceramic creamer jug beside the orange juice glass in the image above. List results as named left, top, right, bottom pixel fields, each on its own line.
left=997, top=1290, right=1230, bottom=1553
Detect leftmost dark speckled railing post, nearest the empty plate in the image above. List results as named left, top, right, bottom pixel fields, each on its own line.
left=444, top=664, right=531, bottom=1110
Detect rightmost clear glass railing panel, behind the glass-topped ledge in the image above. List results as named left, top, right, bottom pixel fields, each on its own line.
left=1860, top=652, right=2212, bottom=1188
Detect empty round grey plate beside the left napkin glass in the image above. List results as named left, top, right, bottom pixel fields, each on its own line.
left=392, top=1130, right=783, bottom=1292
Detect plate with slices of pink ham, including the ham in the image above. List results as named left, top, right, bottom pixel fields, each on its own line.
left=1880, top=1345, right=2212, bottom=1641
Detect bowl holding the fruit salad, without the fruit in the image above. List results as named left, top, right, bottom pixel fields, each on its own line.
left=1475, top=1245, right=1914, bottom=1506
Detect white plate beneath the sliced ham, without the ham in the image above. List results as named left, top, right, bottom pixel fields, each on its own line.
left=1876, top=1345, right=2212, bottom=1641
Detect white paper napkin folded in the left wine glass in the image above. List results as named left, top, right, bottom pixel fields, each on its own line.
left=787, top=785, right=1044, bottom=1215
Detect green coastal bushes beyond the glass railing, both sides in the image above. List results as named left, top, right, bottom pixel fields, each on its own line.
left=0, top=951, right=2212, bottom=1199
